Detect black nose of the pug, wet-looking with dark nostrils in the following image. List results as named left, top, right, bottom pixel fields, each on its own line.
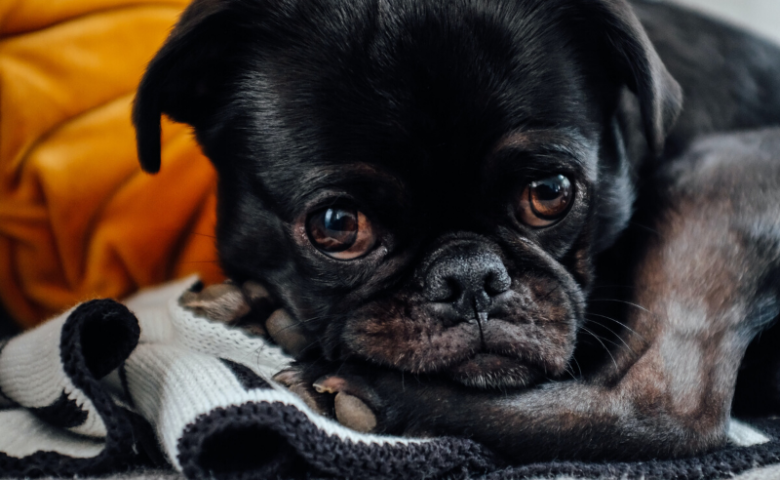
left=425, top=251, right=512, bottom=321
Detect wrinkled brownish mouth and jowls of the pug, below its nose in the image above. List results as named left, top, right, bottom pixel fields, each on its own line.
left=342, top=312, right=573, bottom=389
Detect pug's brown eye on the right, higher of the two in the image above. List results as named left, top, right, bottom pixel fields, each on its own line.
left=517, top=175, right=573, bottom=227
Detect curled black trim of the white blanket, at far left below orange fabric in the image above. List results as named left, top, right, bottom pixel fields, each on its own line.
left=0, top=300, right=140, bottom=478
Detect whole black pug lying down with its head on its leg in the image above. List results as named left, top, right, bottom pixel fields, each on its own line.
left=134, top=0, right=780, bottom=460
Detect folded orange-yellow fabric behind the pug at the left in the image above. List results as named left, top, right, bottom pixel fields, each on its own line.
left=0, top=0, right=221, bottom=327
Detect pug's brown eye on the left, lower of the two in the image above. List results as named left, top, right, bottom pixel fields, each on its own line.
left=306, top=207, right=376, bottom=260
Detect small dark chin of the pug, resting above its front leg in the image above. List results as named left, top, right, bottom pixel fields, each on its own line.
left=447, top=353, right=543, bottom=390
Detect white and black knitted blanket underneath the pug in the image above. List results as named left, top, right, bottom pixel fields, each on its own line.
left=0, top=279, right=780, bottom=480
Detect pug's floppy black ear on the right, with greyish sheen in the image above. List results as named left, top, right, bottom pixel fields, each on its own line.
left=588, top=0, right=683, bottom=155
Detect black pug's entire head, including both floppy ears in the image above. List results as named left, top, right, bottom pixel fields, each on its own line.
left=134, top=0, right=679, bottom=387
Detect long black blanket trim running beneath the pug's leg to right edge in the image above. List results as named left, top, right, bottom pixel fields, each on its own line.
left=172, top=403, right=780, bottom=480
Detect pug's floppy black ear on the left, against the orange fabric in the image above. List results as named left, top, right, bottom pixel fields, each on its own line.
left=133, top=0, right=232, bottom=173
